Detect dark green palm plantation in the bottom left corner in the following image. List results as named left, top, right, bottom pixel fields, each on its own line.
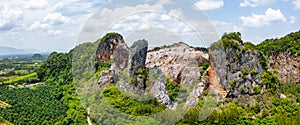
left=0, top=86, right=67, bottom=124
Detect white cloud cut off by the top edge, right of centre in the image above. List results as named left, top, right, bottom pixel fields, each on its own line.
left=194, top=0, right=224, bottom=10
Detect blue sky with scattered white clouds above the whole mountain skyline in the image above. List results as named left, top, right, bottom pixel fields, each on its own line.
left=0, top=0, right=300, bottom=52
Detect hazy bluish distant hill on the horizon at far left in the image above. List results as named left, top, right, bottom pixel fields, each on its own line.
left=0, top=46, right=39, bottom=55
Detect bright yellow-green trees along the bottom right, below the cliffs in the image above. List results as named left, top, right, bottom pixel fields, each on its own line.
left=177, top=92, right=300, bottom=125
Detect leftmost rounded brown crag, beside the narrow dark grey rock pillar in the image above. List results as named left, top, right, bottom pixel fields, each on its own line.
left=95, top=33, right=129, bottom=89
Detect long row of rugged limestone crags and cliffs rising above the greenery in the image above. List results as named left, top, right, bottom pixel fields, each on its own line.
left=96, top=33, right=299, bottom=106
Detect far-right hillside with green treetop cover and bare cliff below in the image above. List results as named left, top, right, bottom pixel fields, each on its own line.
left=256, top=31, right=300, bottom=84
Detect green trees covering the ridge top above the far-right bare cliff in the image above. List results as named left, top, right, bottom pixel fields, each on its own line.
left=256, top=31, right=300, bottom=57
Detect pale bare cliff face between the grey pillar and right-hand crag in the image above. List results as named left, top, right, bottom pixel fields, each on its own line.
left=146, top=42, right=208, bottom=106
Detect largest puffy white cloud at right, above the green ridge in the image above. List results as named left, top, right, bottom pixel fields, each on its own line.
left=239, top=8, right=286, bottom=28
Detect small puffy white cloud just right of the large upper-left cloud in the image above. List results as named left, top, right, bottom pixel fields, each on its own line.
left=43, top=12, right=70, bottom=25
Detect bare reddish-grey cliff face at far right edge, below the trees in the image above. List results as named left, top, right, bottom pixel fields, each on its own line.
left=268, top=52, right=300, bottom=84
